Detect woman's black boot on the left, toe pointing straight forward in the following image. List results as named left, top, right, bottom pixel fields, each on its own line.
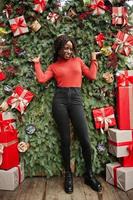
left=64, top=171, right=73, bottom=194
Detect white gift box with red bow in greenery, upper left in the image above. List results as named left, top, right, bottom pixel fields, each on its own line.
left=9, top=16, right=29, bottom=36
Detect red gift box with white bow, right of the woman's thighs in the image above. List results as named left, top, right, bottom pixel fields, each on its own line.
left=92, top=106, right=116, bottom=130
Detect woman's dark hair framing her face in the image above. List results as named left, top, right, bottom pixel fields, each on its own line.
left=53, top=35, right=77, bottom=62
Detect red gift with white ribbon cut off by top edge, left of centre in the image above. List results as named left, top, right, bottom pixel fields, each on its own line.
left=33, top=0, right=47, bottom=13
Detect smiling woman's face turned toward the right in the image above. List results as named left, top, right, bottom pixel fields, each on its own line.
left=59, top=41, right=73, bottom=60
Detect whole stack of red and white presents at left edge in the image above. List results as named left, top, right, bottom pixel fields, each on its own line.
left=0, top=112, right=24, bottom=190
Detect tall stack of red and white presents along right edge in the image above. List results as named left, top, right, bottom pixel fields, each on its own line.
left=106, top=70, right=133, bottom=191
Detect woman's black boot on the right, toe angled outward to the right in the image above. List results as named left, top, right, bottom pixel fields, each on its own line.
left=84, top=172, right=102, bottom=192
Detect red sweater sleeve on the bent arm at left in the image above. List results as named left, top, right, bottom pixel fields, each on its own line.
left=34, top=62, right=54, bottom=83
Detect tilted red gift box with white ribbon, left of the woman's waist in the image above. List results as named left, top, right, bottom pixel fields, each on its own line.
left=7, top=86, right=34, bottom=114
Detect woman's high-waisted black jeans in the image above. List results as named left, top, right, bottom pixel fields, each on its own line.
left=52, top=87, right=92, bottom=172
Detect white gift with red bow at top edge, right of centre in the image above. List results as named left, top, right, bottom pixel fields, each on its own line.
left=89, top=0, right=107, bottom=15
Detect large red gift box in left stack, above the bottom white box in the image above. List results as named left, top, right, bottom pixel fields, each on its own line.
left=0, top=130, right=19, bottom=169
